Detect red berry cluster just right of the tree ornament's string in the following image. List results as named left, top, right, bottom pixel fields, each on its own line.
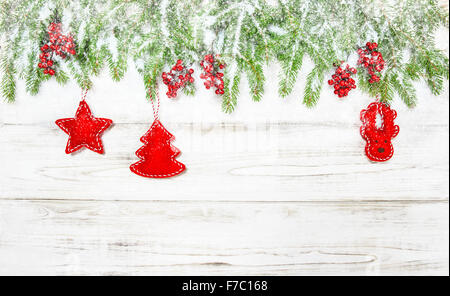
left=162, top=60, right=194, bottom=98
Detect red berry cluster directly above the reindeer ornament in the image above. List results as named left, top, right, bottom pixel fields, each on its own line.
left=358, top=42, right=384, bottom=83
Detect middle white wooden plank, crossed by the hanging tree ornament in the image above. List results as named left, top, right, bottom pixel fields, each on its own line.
left=0, top=123, right=449, bottom=201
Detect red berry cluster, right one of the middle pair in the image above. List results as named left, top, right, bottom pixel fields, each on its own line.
left=200, top=54, right=225, bottom=95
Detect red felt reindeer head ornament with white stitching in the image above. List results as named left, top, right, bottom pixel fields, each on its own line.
left=360, top=102, right=400, bottom=162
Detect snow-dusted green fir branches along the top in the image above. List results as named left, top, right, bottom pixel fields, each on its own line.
left=0, top=0, right=449, bottom=112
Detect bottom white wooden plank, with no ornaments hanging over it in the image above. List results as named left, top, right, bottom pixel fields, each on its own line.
left=0, top=200, right=449, bottom=275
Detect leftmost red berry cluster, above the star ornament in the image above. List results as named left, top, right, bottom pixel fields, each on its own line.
left=38, top=22, right=75, bottom=76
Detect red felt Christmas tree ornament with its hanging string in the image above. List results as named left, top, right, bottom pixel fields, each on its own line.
left=130, top=89, right=186, bottom=178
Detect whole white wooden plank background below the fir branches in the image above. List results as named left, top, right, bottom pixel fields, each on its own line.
left=0, top=24, right=449, bottom=275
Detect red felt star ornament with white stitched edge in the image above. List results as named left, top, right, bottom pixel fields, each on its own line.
left=55, top=100, right=112, bottom=154
